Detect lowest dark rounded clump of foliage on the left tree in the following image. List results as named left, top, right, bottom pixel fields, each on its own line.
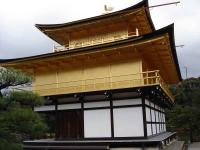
left=0, top=108, right=47, bottom=142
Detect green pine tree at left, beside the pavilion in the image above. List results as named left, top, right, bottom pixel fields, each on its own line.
left=0, top=69, right=47, bottom=150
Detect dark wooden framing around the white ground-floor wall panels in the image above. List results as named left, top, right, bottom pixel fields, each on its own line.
left=42, top=96, right=170, bottom=139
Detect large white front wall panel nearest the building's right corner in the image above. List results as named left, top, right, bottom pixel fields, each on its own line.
left=113, top=107, right=144, bottom=137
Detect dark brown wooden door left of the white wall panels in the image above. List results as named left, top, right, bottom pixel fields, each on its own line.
left=56, top=110, right=83, bottom=139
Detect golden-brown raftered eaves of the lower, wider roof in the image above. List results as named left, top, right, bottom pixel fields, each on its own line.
left=1, top=25, right=181, bottom=83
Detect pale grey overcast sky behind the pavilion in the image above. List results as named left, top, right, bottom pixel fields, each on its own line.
left=0, top=0, right=200, bottom=78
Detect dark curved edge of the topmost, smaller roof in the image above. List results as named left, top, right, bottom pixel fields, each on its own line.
left=35, top=0, right=155, bottom=31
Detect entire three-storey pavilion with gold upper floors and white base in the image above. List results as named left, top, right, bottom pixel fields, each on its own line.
left=0, top=0, right=182, bottom=150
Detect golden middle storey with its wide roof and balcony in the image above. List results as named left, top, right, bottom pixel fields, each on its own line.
left=0, top=25, right=181, bottom=101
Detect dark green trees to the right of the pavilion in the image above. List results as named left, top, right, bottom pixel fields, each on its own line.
left=167, top=78, right=200, bottom=142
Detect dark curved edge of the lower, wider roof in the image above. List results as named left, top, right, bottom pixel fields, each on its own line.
left=0, top=24, right=182, bottom=81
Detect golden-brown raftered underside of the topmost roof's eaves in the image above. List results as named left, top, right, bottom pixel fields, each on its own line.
left=39, top=2, right=154, bottom=45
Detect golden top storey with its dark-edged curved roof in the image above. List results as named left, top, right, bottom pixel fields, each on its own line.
left=36, top=0, right=155, bottom=52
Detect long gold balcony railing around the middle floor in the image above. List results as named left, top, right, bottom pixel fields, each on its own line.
left=33, top=70, right=173, bottom=100
